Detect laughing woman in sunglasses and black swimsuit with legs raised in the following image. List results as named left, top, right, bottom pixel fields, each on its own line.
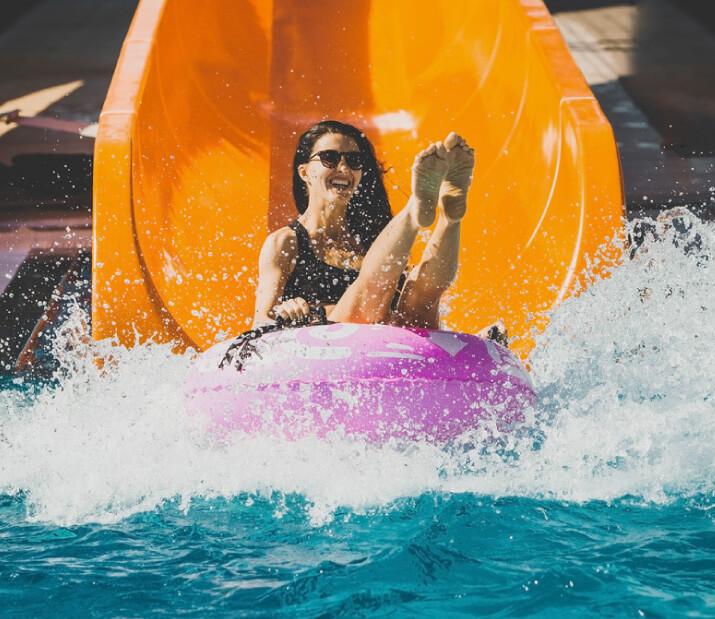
left=254, top=121, right=482, bottom=329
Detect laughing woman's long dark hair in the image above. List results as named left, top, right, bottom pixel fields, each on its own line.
left=293, top=120, right=392, bottom=249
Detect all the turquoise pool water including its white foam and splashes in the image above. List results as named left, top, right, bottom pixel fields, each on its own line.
left=0, top=217, right=715, bottom=617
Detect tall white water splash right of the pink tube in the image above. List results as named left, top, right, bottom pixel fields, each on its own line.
left=514, top=208, right=715, bottom=501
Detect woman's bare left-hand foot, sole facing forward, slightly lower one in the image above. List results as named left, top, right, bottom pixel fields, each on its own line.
left=412, top=142, right=449, bottom=228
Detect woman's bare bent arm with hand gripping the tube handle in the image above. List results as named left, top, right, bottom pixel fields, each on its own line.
left=253, top=228, right=308, bottom=328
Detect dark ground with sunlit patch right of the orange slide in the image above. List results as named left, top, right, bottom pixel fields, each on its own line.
left=546, top=0, right=715, bottom=219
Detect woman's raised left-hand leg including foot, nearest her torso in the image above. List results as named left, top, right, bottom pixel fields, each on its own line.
left=328, top=142, right=449, bottom=323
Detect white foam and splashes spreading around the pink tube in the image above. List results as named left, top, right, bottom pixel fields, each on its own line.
left=0, top=213, right=715, bottom=526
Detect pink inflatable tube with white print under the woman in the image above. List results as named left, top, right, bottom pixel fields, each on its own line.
left=185, top=323, right=535, bottom=442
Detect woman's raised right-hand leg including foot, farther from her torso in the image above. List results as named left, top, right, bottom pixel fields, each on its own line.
left=397, top=133, right=474, bottom=329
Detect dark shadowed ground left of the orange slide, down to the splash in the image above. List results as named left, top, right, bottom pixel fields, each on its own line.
left=0, top=0, right=137, bottom=373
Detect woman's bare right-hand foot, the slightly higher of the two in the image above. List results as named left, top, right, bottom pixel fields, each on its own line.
left=439, top=132, right=474, bottom=222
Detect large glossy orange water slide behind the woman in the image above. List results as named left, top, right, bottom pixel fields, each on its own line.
left=92, top=0, right=623, bottom=354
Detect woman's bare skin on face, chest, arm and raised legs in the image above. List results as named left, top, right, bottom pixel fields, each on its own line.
left=254, top=133, right=506, bottom=336
